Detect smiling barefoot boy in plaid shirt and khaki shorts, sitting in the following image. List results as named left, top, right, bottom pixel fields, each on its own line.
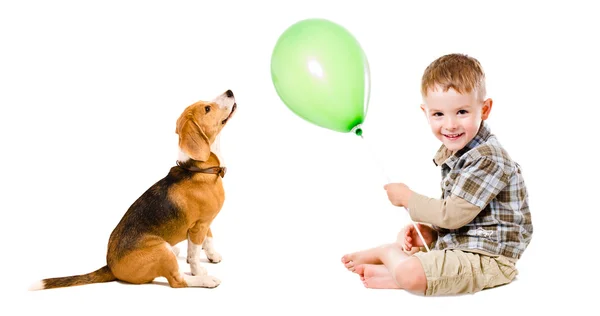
left=342, top=54, right=533, bottom=296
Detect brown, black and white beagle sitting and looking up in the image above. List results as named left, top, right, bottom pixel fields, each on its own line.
left=30, top=90, right=237, bottom=290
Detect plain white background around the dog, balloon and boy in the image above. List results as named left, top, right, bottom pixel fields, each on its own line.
left=0, top=0, right=600, bottom=315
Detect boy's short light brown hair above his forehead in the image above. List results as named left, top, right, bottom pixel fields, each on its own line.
left=421, top=54, right=486, bottom=101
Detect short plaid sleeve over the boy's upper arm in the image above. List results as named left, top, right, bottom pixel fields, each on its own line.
left=451, top=157, right=508, bottom=209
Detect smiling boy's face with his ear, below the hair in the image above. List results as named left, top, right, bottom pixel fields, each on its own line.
left=421, top=89, right=492, bottom=152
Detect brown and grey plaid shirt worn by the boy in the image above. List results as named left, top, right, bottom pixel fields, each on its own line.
left=434, top=121, right=533, bottom=259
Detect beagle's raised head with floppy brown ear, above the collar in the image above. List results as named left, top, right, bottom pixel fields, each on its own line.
left=175, top=90, right=237, bottom=161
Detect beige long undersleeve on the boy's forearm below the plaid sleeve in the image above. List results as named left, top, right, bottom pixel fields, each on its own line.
left=408, top=192, right=481, bottom=229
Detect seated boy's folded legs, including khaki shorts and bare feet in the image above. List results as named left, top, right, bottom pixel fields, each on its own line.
left=344, top=244, right=518, bottom=296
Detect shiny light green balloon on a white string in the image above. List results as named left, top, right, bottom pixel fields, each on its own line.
left=271, top=19, right=370, bottom=135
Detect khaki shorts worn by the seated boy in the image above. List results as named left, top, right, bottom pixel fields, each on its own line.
left=414, top=249, right=518, bottom=296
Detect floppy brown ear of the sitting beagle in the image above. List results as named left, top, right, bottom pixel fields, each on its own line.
left=175, top=111, right=210, bottom=161
